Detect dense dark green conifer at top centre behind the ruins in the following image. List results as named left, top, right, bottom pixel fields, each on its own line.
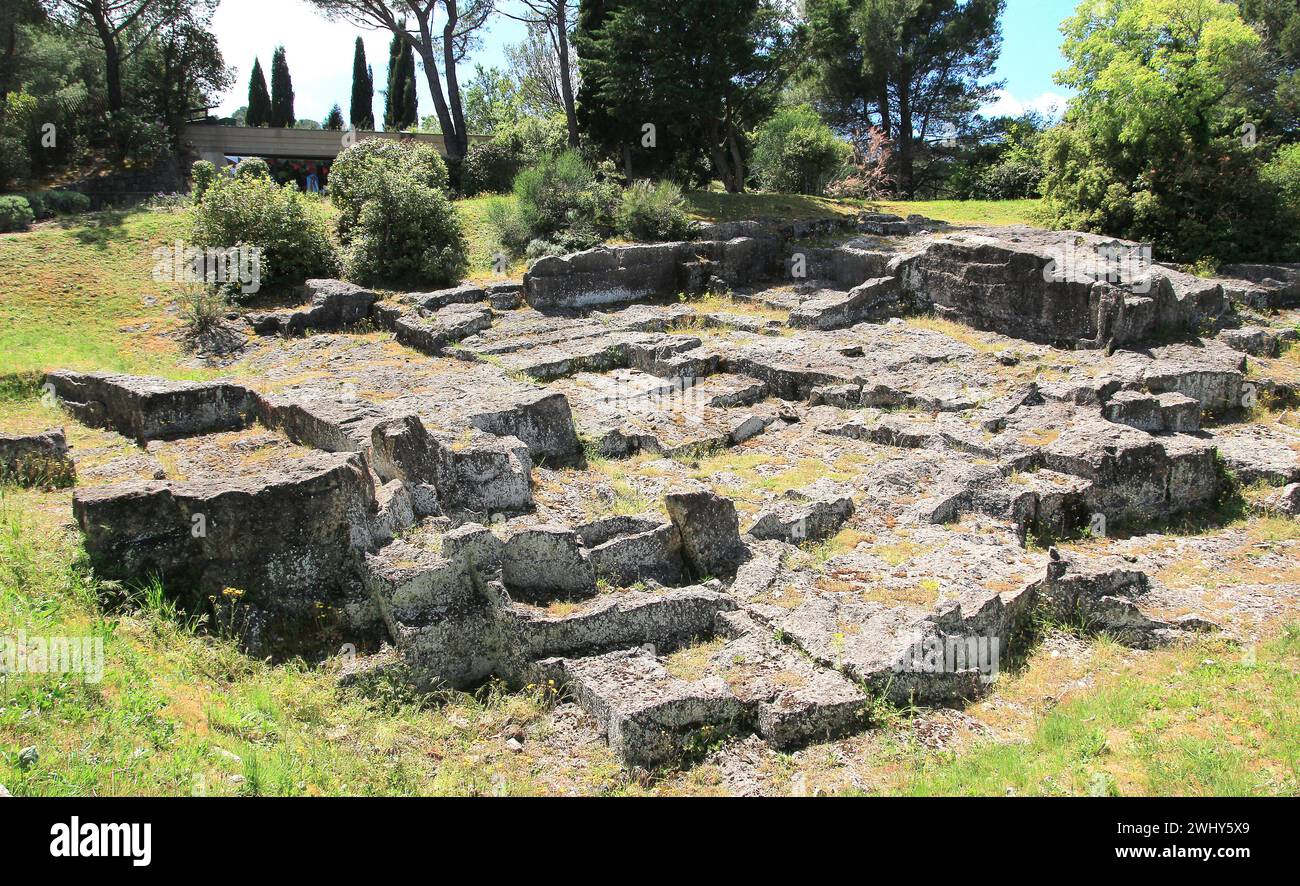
left=575, top=0, right=797, bottom=191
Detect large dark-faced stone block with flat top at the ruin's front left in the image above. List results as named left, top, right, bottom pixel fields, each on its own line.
left=73, top=452, right=376, bottom=655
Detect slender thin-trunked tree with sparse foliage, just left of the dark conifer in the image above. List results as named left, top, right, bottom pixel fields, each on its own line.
left=501, top=0, right=579, bottom=148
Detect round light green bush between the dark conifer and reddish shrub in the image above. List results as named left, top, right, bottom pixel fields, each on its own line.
left=751, top=105, right=853, bottom=194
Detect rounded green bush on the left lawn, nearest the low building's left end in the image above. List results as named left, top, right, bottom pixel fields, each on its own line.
left=191, top=170, right=338, bottom=285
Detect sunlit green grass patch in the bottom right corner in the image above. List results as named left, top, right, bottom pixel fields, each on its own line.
left=897, top=626, right=1300, bottom=796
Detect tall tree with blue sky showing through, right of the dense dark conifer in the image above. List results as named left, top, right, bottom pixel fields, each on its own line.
left=809, top=0, right=1005, bottom=196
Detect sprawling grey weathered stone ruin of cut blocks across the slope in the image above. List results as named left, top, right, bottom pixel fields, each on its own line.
left=27, top=216, right=1300, bottom=766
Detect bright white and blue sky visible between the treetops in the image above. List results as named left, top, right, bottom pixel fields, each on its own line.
left=212, top=0, right=1078, bottom=126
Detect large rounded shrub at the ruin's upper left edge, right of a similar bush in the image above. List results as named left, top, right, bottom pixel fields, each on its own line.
left=345, top=169, right=465, bottom=286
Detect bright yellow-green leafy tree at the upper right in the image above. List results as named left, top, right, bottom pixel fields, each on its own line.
left=1043, top=0, right=1288, bottom=261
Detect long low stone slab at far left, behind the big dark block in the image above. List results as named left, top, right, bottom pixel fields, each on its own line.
left=46, top=370, right=255, bottom=443
